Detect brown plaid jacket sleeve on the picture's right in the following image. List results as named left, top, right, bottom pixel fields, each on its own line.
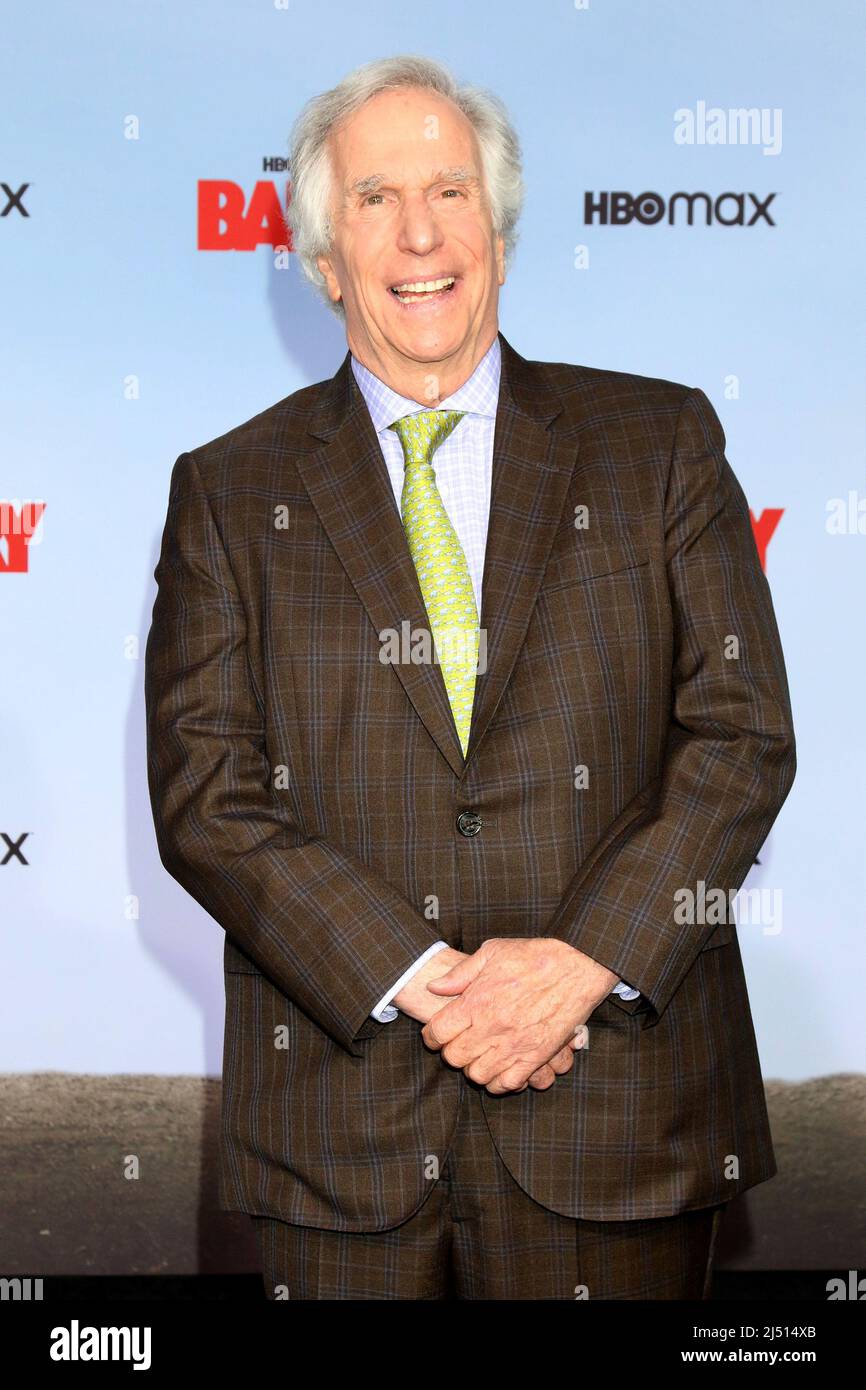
left=549, top=391, right=796, bottom=1026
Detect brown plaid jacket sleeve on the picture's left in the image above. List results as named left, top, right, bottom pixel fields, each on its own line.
left=145, top=453, right=441, bottom=1055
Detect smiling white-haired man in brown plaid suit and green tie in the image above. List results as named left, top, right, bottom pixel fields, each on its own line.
left=146, top=57, right=795, bottom=1300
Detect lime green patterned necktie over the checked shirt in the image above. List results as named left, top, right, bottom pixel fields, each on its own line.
left=388, top=410, right=480, bottom=758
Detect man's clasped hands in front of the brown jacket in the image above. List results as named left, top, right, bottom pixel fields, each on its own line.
left=393, top=937, right=619, bottom=1095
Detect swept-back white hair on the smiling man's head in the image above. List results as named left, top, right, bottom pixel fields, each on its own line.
left=286, top=54, right=524, bottom=318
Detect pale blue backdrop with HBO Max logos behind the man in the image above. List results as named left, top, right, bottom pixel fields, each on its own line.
left=0, top=0, right=866, bottom=1273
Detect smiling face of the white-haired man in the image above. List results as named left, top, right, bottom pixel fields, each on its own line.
left=317, top=88, right=505, bottom=384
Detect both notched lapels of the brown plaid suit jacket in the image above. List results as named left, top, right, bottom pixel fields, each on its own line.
left=296, top=334, right=577, bottom=778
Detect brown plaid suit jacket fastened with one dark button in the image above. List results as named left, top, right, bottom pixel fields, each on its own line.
left=146, top=335, right=795, bottom=1230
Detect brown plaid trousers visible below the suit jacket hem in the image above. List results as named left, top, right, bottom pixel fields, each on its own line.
left=252, top=1081, right=726, bottom=1302
